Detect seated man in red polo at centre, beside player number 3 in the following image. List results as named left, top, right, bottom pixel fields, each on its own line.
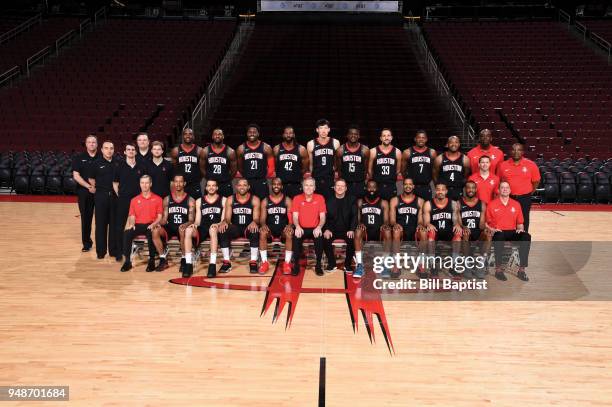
left=283, top=178, right=326, bottom=276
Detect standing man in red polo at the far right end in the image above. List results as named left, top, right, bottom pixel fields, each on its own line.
left=498, top=143, right=541, bottom=232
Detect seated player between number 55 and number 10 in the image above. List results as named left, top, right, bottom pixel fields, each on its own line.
left=183, top=179, right=227, bottom=278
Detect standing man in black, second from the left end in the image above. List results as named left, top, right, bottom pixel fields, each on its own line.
left=89, top=141, right=121, bottom=259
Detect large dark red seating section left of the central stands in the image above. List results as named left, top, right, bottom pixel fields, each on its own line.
left=0, top=20, right=235, bottom=152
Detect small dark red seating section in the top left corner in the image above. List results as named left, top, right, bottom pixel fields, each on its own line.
left=0, top=17, right=81, bottom=73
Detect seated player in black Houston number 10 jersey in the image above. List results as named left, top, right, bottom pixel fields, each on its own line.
left=217, top=178, right=260, bottom=274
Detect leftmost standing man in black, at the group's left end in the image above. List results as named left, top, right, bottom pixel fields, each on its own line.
left=72, top=134, right=101, bottom=252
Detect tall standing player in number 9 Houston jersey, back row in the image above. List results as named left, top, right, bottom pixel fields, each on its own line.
left=306, top=119, right=340, bottom=198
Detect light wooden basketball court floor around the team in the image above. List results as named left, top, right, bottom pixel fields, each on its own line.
left=0, top=202, right=612, bottom=406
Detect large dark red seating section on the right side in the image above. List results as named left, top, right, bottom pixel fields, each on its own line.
left=424, top=22, right=612, bottom=160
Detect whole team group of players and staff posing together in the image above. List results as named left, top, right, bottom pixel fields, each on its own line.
left=72, top=119, right=540, bottom=281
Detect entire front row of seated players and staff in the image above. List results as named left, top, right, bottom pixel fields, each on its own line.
left=121, top=174, right=530, bottom=281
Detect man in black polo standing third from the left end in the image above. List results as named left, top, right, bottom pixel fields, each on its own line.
left=113, top=144, right=145, bottom=261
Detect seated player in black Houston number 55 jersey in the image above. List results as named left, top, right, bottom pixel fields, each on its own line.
left=153, top=174, right=195, bottom=273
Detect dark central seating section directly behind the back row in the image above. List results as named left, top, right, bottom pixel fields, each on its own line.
left=211, top=24, right=454, bottom=147
